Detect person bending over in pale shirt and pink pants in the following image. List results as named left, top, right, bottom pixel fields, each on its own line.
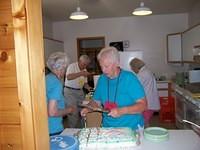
left=130, top=58, right=160, bottom=127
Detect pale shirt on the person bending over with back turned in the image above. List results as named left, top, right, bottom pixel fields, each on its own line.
left=137, top=66, right=160, bottom=110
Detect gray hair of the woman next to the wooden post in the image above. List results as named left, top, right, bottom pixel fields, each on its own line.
left=47, top=52, right=69, bottom=72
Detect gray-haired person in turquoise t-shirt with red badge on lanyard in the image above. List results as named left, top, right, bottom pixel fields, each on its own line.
left=81, top=47, right=147, bottom=129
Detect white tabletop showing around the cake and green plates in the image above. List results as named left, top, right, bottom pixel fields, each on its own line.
left=61, top=128, right=200, bottom=150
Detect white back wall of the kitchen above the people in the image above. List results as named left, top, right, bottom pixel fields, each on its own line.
left=53, top=14, right=188, bottom=78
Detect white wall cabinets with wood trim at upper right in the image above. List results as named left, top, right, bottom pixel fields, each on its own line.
left=167, top=24, right=200, bottom=63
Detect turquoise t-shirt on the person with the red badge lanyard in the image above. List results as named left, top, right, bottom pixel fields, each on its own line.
left=93, top=70, right=145, bottom=129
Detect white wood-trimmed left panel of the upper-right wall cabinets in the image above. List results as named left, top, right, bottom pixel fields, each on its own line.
left=167, top=33, right=182, bottom=63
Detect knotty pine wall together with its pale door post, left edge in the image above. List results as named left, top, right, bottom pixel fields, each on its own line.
left=0, top=0, right=49, bottom=150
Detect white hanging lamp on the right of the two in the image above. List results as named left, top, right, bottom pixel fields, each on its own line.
left=132, top=2, right=152, bottom=16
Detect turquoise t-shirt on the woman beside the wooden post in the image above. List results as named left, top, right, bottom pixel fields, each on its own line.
left=46, top=73, right=65, bottom=134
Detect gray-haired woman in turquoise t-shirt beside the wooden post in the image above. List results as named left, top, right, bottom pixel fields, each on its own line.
left=46, top=52, right=74, bottom=136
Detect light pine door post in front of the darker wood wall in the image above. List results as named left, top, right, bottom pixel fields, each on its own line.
left=11, top=0, right=49, bottom=150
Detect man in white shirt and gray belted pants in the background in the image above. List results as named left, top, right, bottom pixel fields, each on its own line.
left=64, top=55, right=92, bottom=128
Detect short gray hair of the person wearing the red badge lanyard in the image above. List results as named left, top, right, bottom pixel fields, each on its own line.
left=97, top=47, right=120, bottom=65
